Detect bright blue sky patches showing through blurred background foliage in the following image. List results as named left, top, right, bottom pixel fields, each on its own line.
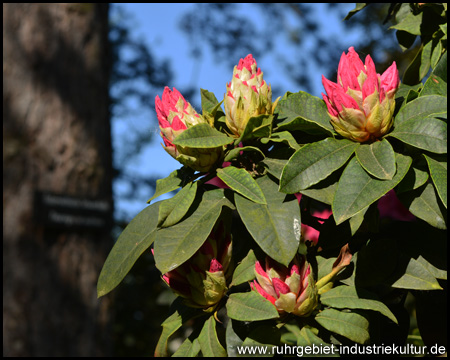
left=113, top=3, right=357, bottom=220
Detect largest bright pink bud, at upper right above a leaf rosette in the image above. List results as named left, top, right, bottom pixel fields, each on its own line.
left=322, top=47, right=400, bottom=142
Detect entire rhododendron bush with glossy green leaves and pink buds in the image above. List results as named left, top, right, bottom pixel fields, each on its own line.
left=98, top=4, right=447, bottom=356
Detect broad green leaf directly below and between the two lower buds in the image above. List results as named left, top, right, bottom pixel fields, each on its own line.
left=226, top=291, right=279, bottom=321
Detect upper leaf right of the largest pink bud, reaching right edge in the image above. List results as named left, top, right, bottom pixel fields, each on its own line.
left=389, top=95, right=447, bottom=127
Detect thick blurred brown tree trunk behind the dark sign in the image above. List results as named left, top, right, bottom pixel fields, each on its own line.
left=3, top=4, right=112, bottom=356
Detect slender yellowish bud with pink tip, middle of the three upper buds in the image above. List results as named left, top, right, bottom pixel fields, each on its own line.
left=224, top=54, right=278, bottom=137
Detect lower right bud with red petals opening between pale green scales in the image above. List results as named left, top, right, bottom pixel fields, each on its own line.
left=250, top=256, right=318, bottom=316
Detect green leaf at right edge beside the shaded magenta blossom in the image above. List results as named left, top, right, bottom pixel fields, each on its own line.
left=408, top=184, right=447, bottom=229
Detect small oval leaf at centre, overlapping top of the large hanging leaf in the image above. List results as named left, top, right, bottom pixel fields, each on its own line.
left=217, top=166, right=267, bottom=204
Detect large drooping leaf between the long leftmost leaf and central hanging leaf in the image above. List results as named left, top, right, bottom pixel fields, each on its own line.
left=154, top=189, right=233, bottom=274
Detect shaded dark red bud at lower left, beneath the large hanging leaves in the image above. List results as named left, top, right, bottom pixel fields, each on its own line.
left=156, top=223, right=232, bottom=311
